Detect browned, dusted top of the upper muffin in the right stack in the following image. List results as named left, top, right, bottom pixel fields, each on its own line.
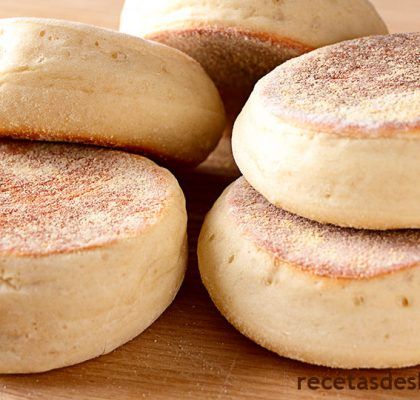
left=258, top=33, right=420, bottom=137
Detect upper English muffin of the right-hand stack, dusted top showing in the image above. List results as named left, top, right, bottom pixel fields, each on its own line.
left=233, top=33, right=420, bottom=229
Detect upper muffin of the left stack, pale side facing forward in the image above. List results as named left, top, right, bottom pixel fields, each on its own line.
left=0, top=18, right=225, bottom=166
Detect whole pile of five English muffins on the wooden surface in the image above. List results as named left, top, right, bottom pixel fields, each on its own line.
left=0, top=0, right=420, bottom=373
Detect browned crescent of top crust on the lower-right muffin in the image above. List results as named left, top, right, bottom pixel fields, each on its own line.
left=227, top=178, right=420, bottom=279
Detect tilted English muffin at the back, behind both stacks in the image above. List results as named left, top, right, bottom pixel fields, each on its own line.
left=120, top=0, right=387, bottom=116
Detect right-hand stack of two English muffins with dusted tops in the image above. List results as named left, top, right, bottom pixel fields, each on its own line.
left=198, top=33, right=420, bottom=368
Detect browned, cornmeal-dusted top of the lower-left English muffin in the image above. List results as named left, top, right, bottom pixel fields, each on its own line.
left=0, top=140, right=170, bottom=256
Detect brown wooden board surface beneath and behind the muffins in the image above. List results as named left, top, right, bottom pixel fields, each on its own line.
left=0, top=0, right=420, bottom=400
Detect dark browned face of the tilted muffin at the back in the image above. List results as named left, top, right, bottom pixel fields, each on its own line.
left=146, top=26, right=313, bottom=117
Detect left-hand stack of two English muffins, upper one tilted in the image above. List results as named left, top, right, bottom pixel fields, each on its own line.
left=0, top=18, right=225, bottom=373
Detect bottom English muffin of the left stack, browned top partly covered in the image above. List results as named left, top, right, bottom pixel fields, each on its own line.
left=0, top=141, right=187, bottom=373
